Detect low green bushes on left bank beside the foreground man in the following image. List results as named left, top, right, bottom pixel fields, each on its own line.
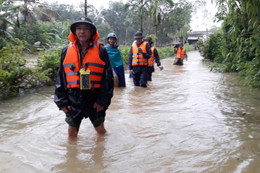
left=0, top=39, right=61, bottom=98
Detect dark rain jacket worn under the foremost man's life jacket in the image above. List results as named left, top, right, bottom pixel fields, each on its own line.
left=54, top=33, right=114, bottom=114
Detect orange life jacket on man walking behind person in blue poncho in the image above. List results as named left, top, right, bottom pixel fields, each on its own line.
left=132, top=41, right=148, bottom=66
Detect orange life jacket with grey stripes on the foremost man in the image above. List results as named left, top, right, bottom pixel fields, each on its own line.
left=63, top=42, right=106, bottom=88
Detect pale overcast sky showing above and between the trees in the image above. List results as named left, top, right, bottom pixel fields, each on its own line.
left=44, top=0, right=220, bottom=31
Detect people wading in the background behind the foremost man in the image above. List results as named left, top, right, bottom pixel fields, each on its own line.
left=105, top=31, right=187, bottom=88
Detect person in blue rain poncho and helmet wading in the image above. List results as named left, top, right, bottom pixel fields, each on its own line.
left=105, top=33, right=125, bottom=87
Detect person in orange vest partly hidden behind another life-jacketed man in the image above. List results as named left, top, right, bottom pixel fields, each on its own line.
left=144, top=37, right=163, bottom=81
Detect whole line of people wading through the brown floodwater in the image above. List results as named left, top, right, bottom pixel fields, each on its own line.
left=54, top=16, right=186, bottom=139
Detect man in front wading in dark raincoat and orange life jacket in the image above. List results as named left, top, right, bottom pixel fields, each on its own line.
left=54, top=16, right=114, bottom=139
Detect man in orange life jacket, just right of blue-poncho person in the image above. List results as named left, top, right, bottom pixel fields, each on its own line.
left=128, top=31, right=152, bottom=88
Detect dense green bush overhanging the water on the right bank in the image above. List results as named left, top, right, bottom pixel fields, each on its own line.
left=197, top=25, right=260, bottom=88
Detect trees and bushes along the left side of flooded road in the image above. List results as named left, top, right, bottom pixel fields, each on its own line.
left=0, top=0, right=192, bottom=98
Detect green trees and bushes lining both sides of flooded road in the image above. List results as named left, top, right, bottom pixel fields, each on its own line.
left=0, top=0, right=260, bottom=98
